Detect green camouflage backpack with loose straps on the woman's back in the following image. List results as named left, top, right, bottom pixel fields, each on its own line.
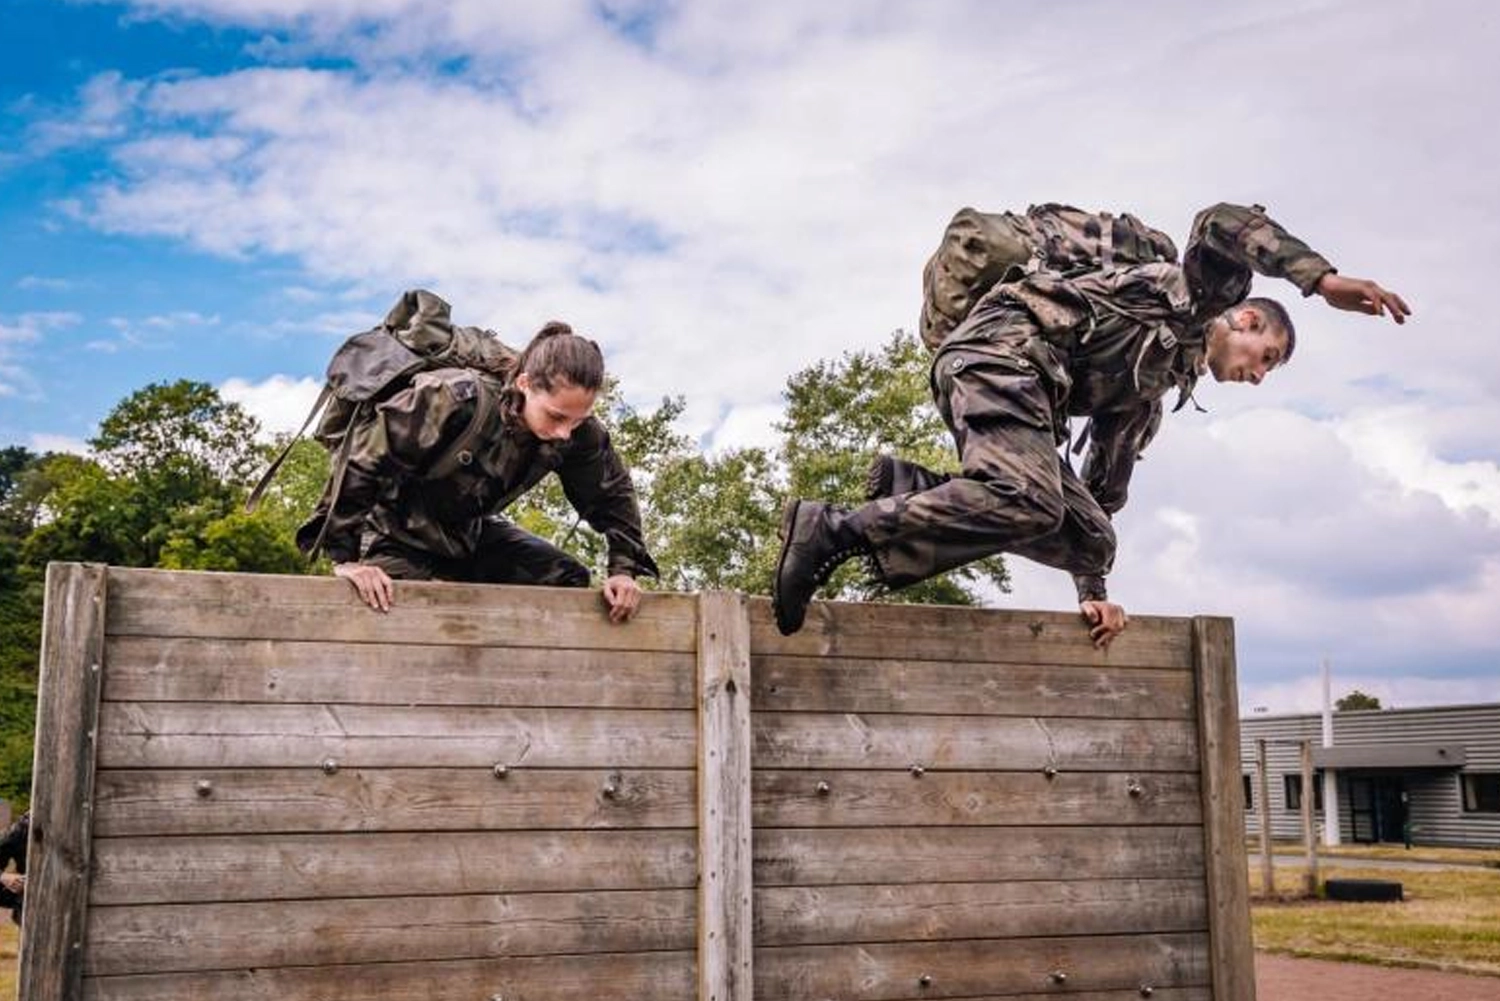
left=245, top=288, right=519, bottom=554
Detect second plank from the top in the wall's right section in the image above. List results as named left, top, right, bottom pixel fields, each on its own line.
left=750, top=654, right=1196, bottom=719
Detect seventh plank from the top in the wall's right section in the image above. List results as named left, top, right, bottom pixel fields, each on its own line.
left=755, top=932, right=1209, bottom=1001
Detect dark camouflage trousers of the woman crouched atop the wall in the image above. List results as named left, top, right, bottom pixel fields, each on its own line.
left=360, top=518, right=588, bottom=587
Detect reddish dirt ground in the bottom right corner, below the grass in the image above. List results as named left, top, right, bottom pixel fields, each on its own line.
left=1256, top=953, right=1500, bottom=1001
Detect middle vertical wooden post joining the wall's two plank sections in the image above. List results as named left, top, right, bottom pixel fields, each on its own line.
left=698, top=591, right=752, bottom=1001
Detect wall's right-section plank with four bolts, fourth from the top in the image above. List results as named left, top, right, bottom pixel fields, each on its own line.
left=755, top=770, right=1203, bottom=828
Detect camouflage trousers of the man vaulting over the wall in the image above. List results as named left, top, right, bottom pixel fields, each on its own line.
left=855, top=344, right=1115, bottom=600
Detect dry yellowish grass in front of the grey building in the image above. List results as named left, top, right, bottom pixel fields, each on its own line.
left=1250, top=861, right=1500, bottom=977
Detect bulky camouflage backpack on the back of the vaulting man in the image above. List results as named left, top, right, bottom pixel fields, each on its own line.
left=921, top=203, right=1178, bottom=351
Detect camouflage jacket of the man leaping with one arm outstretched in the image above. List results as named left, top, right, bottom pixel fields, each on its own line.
left=939, top=204, right=1334, bottom=596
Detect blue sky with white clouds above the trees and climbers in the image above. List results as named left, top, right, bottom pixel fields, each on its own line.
left=0, top=0, right=1500, bottom=710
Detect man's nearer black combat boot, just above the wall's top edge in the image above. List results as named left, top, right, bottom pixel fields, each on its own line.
left=771, top=500, right=873, bottom=636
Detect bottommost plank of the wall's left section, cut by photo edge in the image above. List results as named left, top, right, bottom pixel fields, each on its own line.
left=83, top=954, right=695, bottom=1001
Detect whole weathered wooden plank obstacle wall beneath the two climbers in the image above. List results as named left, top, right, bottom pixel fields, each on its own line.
left=23, top=566, right=1254, bottom=1001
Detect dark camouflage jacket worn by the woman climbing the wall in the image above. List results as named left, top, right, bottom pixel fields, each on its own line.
left=297, top=369, right=657, bottom=576
